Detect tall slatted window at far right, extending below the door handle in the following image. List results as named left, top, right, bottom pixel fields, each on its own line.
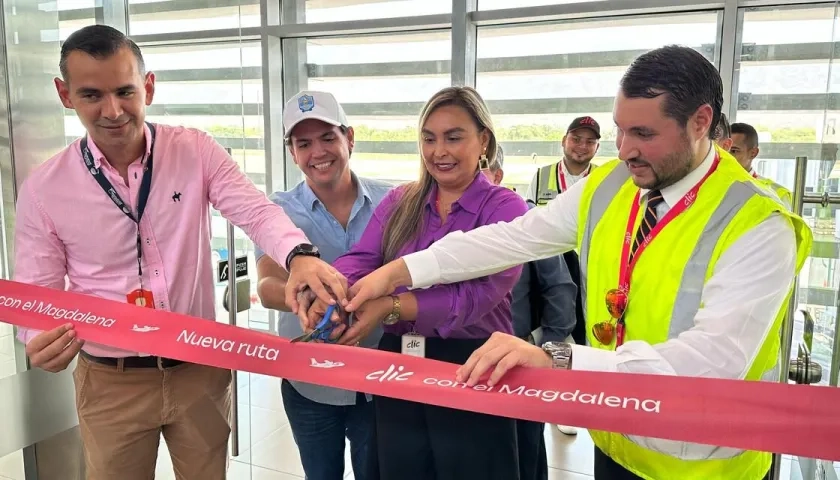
left=735, top=6, right=840, bottom=384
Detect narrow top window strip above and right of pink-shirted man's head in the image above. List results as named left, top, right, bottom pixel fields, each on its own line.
left=128, top=0, right=260, bottom=35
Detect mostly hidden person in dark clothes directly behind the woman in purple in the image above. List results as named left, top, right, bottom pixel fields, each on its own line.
left=484, top=146, right=577, bottom=480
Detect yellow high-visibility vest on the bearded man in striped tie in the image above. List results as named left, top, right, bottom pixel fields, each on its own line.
left=578, top=149, right=813, bottom=480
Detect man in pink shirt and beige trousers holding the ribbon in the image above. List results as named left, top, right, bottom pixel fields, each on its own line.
left=15, top=25, right=346, bottom=480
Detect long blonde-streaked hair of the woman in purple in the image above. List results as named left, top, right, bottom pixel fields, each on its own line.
left=382, top=87, right=496, bottom=262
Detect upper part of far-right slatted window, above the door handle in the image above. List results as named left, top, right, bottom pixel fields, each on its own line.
left=736, top=7, right=840, bottom=188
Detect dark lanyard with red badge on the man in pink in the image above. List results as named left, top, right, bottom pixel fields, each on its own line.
left=80, top=122, right=155, bottom=308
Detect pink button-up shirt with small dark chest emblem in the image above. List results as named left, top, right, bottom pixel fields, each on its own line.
left=14, top=124, right=308, bottom=357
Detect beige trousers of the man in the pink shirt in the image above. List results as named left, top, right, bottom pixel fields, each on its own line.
left=73, top=355, right=231, bottom=480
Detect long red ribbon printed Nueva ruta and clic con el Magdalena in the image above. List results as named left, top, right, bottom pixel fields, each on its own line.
left=0, top=280, right=840, bottom=460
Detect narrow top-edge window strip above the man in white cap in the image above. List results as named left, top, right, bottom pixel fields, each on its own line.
left=304, top=0, right=452, bottom=23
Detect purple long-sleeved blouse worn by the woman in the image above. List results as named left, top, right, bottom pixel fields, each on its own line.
left=333, top=172, right=528, bottom=338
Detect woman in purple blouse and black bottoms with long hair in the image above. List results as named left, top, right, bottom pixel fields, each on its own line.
left=306, top=87, right=528, bottom=480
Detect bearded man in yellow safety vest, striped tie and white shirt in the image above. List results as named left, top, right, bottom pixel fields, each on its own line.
left=345, top=46, right=813, bottom=480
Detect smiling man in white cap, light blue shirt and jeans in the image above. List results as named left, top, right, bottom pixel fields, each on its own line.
left=256, top=91, right=391, bottom=480
